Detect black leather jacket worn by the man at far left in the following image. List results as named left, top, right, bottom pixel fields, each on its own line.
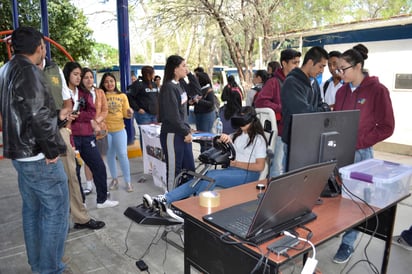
left=0, top=55, right=66, bottom=159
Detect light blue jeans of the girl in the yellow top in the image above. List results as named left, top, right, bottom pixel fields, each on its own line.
left=106, top=129, right=131, bottom=183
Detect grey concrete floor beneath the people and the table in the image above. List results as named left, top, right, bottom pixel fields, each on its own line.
left=0, top=146, right=412, bottom=274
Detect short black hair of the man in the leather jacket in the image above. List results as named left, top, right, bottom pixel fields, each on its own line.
left=11, top=27, right=44, bottom=55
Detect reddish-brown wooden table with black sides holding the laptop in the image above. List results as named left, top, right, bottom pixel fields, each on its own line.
left=173, top=181, right=407, bottom=273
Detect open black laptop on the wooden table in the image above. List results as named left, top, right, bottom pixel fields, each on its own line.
left=203, top=161, right=336, bottom=244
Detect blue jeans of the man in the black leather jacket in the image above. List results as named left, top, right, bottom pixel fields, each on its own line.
left=12, top=159, right=69, bottom=274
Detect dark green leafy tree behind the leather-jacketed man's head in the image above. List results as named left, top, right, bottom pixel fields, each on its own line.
left=0, top=0, right=95, bottom=66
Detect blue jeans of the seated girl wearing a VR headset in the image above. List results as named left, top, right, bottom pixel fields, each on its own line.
left=165, top=167, right=260, bottom=204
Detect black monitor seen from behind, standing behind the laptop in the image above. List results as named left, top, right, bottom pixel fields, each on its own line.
left=287, top=110, right=360, bottom=171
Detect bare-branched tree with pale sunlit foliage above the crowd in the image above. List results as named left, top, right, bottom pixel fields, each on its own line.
left=132, top=0, right=411, bottom=89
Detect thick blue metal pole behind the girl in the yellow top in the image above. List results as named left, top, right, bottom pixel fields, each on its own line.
left=117, top=0, right=134, bottom=145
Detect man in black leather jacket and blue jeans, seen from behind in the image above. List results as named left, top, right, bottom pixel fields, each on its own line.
left=0, top=27, right=69, bottom=273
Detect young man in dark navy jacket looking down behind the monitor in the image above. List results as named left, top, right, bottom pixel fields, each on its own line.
left=280, top=47, right=330, bottom=168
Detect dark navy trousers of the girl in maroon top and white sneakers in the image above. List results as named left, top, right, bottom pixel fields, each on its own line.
left=73, top=136, right=107, bottom=204
